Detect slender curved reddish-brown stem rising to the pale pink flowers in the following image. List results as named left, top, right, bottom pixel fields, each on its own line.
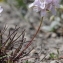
left=14, top=17, right=43, bottom=61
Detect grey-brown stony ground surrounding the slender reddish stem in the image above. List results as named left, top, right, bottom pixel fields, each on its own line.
left=0, top=3, right=63, bottom=63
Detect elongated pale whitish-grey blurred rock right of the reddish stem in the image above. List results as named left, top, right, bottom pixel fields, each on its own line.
left=42, top=19, right=61, bottom=32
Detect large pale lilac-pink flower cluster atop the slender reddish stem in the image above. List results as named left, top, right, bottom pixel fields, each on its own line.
left=29, top=0, right=60, bottom=17
